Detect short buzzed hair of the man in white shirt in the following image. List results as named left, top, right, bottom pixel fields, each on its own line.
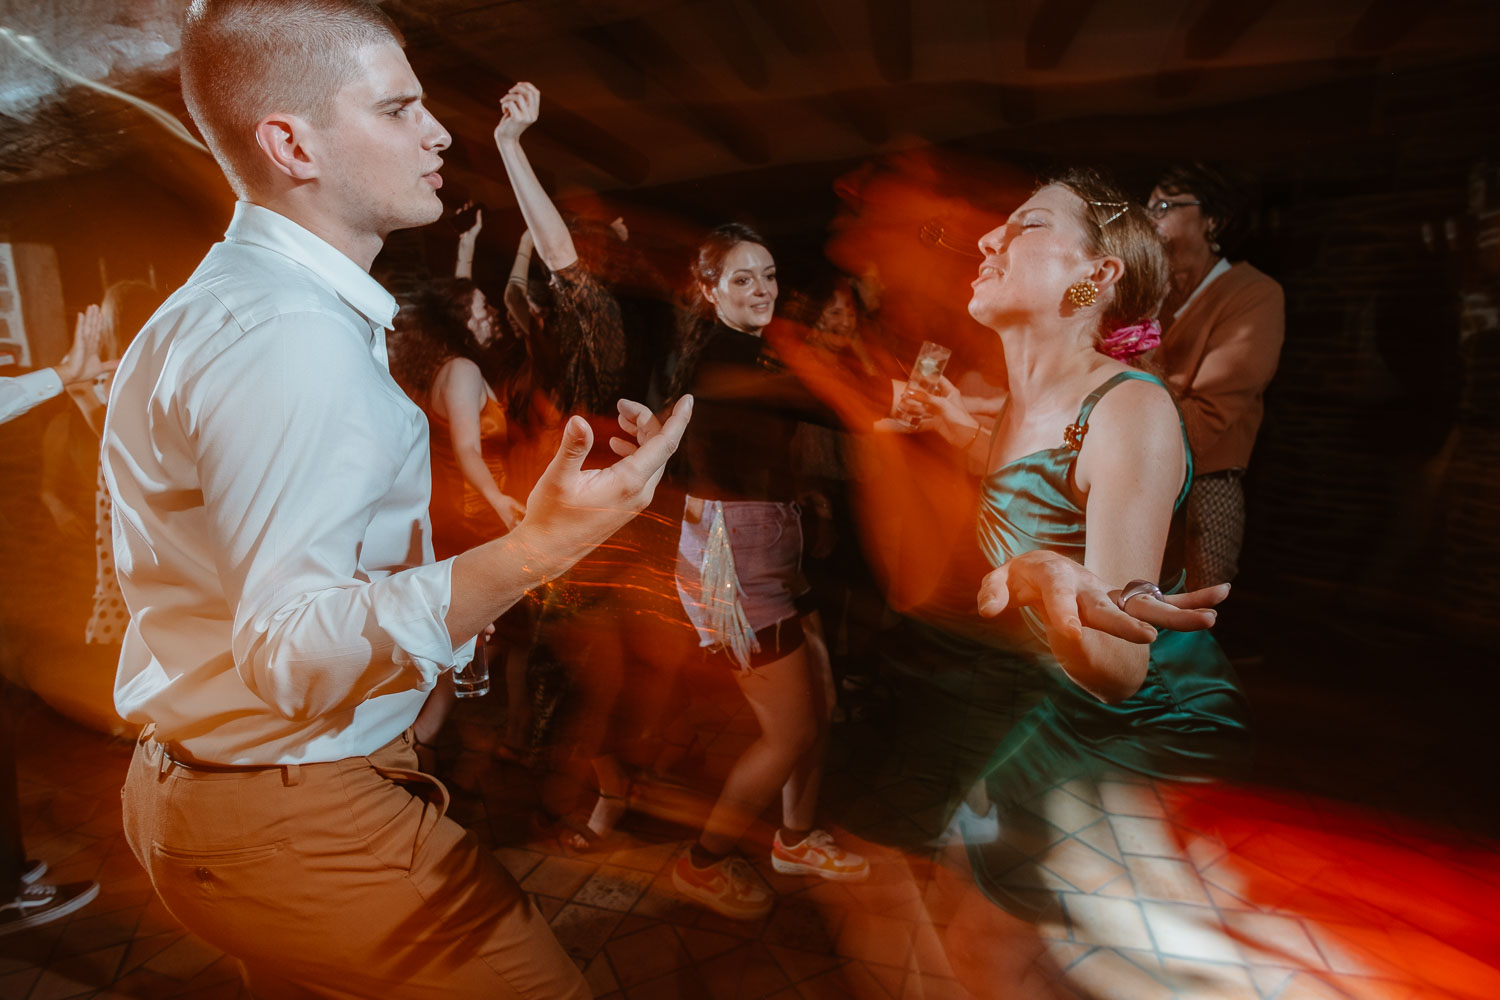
left=182, top=0, right=402, bottom=196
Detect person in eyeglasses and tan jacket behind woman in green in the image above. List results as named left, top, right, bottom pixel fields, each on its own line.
left=1146, top=163, right=1286, bottom=588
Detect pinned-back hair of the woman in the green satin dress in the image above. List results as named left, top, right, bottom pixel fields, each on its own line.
left=1043, top=169, right=1169, bottom=336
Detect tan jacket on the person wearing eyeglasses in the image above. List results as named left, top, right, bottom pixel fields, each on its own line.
left=1157, top=261, right=1287, bottom=475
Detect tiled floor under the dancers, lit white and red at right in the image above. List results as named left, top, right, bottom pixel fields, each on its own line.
left=0, top=668, right=1500, bottom=1000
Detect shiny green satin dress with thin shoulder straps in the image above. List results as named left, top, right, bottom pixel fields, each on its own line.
left=969, top=372, right=1250, bottom=898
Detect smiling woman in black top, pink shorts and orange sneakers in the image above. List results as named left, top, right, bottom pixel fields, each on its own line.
left=672, top=225, right=869, bottom=919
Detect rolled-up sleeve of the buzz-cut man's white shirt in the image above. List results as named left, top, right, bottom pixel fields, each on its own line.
left=189, top=312, right=473, bottom=720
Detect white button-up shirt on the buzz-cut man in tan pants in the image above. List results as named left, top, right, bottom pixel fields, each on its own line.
left=104, top=202, right=473, bottom=765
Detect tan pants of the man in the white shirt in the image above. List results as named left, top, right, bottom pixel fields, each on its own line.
left=122, top=727, right=590, bottom=1000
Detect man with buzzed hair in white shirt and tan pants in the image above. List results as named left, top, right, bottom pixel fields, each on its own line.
left=104, top=0, right=692, bottom=1000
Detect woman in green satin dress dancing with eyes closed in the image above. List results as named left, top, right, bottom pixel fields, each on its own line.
left=912, top=172, right=1248, bottom=995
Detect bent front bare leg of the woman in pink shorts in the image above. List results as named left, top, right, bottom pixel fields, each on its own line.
left=699, top=645, right=818, bottom=855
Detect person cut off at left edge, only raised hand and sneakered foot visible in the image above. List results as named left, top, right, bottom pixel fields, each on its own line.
left=0, top=314, right=116, bottom=936
